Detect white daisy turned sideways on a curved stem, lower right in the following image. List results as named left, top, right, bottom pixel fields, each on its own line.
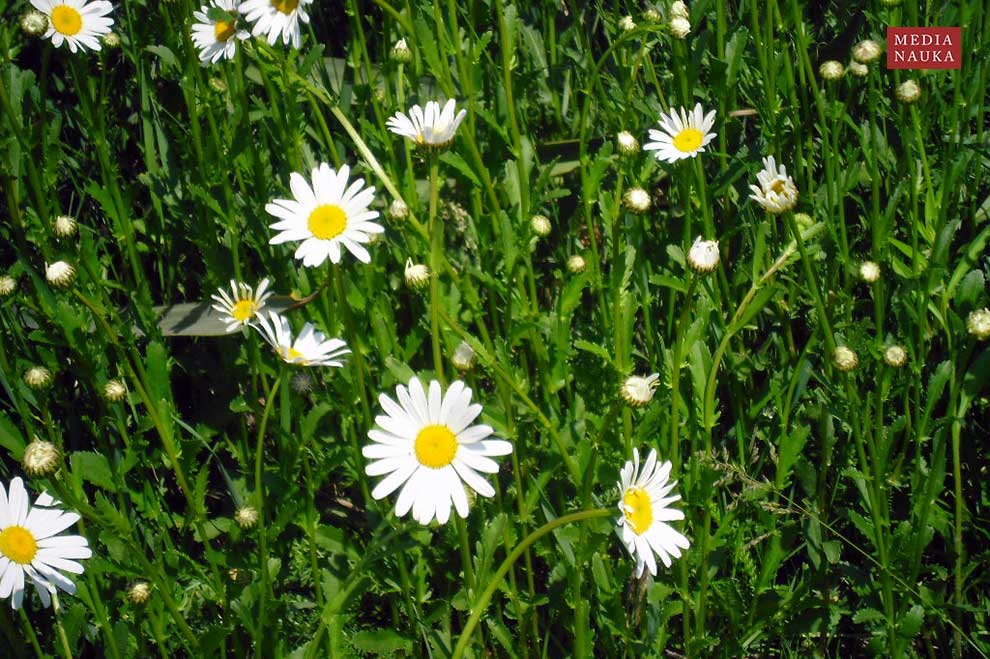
left=617, top=449, right=691, bottom=577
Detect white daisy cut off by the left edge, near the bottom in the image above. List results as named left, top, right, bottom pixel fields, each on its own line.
left=0, top=478, right=93, bottom=609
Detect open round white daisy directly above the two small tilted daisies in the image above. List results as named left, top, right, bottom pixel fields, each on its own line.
left=265, top=163, right=385, bottom=266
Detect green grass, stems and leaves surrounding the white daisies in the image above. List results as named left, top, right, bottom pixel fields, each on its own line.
left=0, top=0, right=990, bottom=657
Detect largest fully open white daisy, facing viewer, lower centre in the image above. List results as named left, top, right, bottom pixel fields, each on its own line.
left=361, top=377, right=512, bottom=525
